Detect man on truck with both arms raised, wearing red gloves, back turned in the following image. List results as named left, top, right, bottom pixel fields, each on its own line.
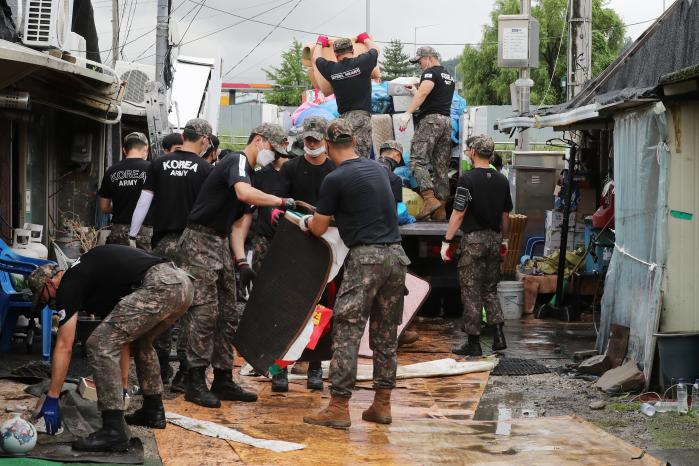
left=313, top=32, right=379, bottom=158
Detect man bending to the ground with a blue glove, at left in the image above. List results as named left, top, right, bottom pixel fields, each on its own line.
left=29, top=244, right=193, bottom=451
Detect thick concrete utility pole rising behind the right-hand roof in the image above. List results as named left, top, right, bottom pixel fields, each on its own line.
left=566, top=0, right=592, bottom=100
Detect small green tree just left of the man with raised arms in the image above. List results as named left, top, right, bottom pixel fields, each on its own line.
left=263, top=39, right=311, bottom=106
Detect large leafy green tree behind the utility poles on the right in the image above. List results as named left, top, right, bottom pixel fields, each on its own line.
left=458, top=0, right=624, bottom=106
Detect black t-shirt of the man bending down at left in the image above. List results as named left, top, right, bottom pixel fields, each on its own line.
left=56, top=244, right=168, bottom=325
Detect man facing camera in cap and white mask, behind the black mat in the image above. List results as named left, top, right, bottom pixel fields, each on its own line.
left=272, top=117, right=335, bottom=392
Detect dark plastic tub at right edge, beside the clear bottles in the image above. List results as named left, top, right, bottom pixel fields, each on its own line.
left=655, top=332, right=699, bottom=389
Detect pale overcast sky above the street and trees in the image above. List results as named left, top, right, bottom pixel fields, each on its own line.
left=93, top=0, right=674, bottom=82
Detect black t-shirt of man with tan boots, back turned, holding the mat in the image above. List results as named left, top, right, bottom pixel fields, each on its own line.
left=317, top=157, right=400, bottom=247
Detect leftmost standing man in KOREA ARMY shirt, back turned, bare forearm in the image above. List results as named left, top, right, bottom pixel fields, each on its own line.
left=98, top=133, right=153, bottom=251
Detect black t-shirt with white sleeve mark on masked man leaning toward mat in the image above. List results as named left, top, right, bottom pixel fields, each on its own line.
left=188, top=152, right=253, bottom=235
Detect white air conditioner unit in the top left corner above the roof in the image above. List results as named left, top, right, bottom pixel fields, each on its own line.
left=22, top=0, right=73, bottom=51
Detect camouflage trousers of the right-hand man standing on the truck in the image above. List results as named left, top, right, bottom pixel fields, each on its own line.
left=409, top=113, right=451, bottom=200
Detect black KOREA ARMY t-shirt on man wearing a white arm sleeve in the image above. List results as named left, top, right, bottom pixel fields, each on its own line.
left=143, top=151, right=213, bottom=238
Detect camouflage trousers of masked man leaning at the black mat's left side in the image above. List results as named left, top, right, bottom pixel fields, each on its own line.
left=177, top=225, right=240, bottom=369
